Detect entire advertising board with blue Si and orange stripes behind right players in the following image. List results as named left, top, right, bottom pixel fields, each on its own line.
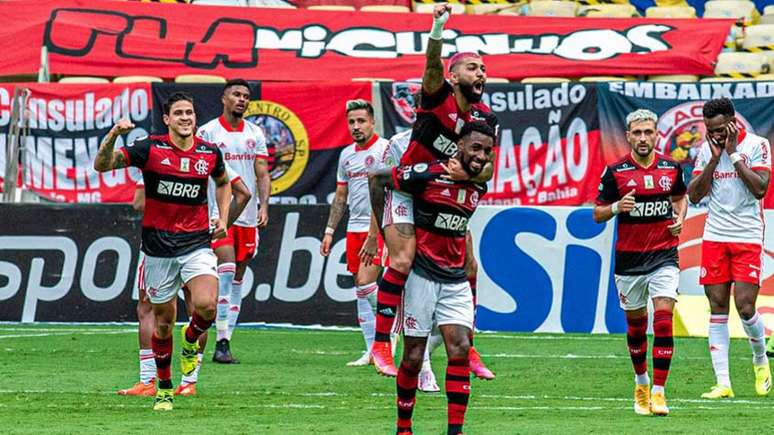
left=470, top=206, right=774, bottom=338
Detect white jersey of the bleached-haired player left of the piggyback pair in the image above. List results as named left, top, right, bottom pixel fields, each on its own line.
left=336, top=135, right=389, bottom=232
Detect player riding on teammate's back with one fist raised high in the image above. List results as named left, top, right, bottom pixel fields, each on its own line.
left=371, top=4, right=497, bottom=379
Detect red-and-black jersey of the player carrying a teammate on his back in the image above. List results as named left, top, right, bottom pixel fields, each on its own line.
left=392, top=162, right=486, bottom=283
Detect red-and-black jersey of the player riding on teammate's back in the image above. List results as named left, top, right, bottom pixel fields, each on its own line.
left=400, top=81, right=499, bottom=165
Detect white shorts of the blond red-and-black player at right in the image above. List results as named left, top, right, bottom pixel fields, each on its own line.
left=615, top=266, right=680, bottom=311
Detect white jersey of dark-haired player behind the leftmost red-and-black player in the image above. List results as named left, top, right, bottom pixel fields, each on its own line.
left=196, top=116, right=269, bottom=227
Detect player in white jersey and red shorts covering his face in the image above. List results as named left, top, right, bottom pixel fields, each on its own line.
left=688, top=98, right=771, bottom=399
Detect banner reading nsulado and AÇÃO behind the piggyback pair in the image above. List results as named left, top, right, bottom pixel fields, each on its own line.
left=379, top=82, right=604, bottom=205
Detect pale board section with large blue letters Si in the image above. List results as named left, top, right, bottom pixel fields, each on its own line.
left=471, top=207, right=626, bottom=333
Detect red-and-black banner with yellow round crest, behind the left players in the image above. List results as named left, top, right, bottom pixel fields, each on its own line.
left=152, top=82, right=371, bottom=204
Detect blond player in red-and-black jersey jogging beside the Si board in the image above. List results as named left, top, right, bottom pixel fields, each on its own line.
left=594, top=109, right=688, bottom=415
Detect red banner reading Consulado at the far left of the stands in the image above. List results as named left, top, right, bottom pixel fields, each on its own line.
left=0, top=83, right=153, bottom=203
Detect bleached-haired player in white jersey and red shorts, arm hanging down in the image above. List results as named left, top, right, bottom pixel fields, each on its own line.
left=320, top=100, right=388, bottom=366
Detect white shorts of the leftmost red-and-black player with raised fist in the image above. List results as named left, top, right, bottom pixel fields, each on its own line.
left=139, top=248, right=218, bottom=304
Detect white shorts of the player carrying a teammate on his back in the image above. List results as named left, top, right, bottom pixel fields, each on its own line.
left=401, top=271, right=473, bottom=337
